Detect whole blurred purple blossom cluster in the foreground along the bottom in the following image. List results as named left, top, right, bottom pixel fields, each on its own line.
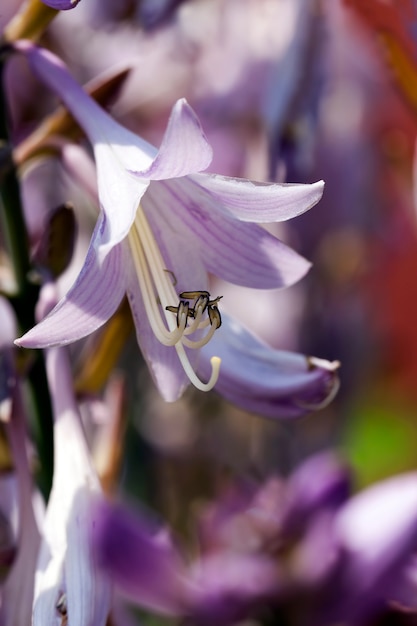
left=92, top=454, right=417, bottom=626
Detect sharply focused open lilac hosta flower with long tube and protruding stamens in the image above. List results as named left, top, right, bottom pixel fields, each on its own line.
left=16, top=42, right=323, bottom=400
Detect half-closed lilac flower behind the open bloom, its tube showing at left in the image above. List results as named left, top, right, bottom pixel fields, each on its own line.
left=61, top=144, right=340, bottom=419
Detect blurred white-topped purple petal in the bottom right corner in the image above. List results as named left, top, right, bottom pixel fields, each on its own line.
left=316, top=472, right=417, bottom=624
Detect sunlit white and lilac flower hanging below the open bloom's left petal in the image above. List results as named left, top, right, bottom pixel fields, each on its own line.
left=33, top=287, right=111, bottom=626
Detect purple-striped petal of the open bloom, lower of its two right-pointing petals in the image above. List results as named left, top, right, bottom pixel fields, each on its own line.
left=143, top=179, right=311, bottom=289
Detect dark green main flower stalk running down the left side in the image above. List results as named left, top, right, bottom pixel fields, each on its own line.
left=0, top=53, right=53, bottom=496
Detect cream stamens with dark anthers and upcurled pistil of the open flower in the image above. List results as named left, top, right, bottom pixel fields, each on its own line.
left=128, top=206, right=221, bottom=391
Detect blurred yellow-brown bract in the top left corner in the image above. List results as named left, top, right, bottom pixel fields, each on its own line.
left=3, top=0, right=59, bottom=43
